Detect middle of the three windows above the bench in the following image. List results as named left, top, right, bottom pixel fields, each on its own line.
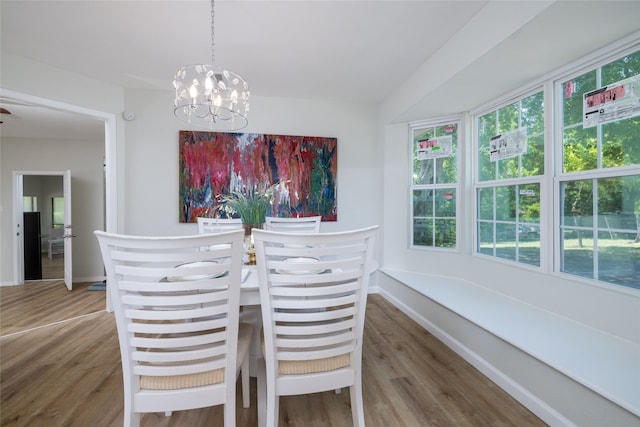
left=475, top=91, right=545, bottom=267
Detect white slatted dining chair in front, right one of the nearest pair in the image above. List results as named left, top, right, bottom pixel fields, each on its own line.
left=253, top=226, right=378, bottom=427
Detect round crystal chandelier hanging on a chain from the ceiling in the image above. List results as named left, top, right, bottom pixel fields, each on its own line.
left=173, top=0, right=249, bottom=131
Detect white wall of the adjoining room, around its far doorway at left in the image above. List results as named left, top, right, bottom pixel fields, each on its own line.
left=0, top=138, right=104, bottom=284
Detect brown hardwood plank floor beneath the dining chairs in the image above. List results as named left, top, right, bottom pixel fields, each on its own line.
left=0, top=285, right=545, bottom=427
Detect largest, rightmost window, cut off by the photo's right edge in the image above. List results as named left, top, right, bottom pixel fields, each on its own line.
left=556, top=51, right=640, bottom=289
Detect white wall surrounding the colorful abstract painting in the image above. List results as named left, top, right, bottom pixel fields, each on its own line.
left=120, top=90, right=382, bottom=235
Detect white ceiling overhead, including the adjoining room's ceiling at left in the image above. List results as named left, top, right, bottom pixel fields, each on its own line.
left=0, top=0, right=640, bottom=139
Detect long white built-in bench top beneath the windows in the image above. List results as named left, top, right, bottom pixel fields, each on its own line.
left=382, top=269, right=640, bottom=417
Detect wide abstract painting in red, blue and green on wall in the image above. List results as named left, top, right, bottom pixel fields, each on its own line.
left=179, top=131, right=338, bottom=223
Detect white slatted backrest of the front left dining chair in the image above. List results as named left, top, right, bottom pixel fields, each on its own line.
left=95, top=230, right=243, bottom=393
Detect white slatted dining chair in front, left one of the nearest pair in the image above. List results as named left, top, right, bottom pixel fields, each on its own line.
left=95, top=230, right=252, bottom=427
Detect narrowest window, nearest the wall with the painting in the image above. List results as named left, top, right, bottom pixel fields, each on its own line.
left=410, top=119, right=460, bottom=248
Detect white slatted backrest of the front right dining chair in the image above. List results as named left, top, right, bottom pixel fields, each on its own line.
left=253, top=227, right=377, bottom=369
